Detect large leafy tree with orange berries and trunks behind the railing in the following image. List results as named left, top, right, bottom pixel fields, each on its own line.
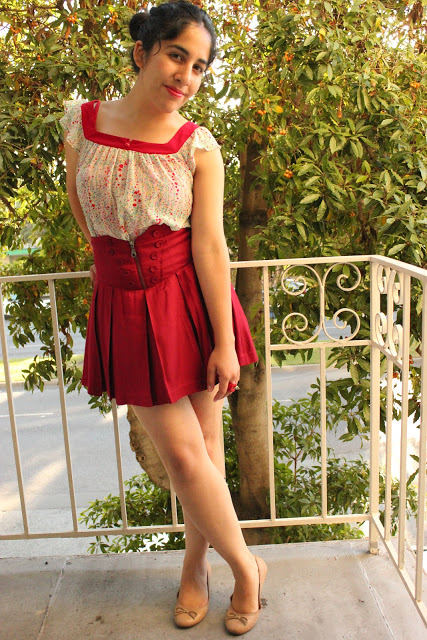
left=0, top=0, right=427, bottom=543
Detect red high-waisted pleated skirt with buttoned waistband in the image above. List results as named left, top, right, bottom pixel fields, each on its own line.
left=82, top=225, right=258, bottom=407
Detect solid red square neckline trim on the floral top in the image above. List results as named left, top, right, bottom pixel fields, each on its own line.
left=81, top=100, right=199, bottom=153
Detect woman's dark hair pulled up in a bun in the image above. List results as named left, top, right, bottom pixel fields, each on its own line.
left=129, top=0, right=216, bottom=73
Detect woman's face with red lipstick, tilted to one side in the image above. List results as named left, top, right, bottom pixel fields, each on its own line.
left=134, top=24, right=211, bottom=113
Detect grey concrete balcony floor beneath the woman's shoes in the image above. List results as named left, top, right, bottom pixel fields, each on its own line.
left=0, top=540, right=427, bottom=640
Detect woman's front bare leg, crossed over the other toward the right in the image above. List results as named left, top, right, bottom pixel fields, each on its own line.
left=133, top=392, right=258, bottom=612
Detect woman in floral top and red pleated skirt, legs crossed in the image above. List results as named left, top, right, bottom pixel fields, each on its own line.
left=62, top=0, right=267, bottom=635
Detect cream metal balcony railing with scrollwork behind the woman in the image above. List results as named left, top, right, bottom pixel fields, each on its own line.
left=0, top=256, right=427, bottom=625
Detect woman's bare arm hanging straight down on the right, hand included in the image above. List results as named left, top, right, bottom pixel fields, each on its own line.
left=191, top=150, right=240, bottom=400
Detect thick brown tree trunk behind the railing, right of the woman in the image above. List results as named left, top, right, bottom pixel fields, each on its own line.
left=229, top=142, right=270, bottom=544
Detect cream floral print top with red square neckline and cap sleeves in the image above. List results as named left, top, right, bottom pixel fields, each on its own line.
left=60, top=100, right=219, bottom=240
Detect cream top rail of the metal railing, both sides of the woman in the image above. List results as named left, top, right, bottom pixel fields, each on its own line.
left=0, top=255, right=427, bottom=285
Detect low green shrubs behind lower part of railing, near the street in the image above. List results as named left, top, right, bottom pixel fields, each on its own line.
left=80, top=402, right=417, bottom=553
